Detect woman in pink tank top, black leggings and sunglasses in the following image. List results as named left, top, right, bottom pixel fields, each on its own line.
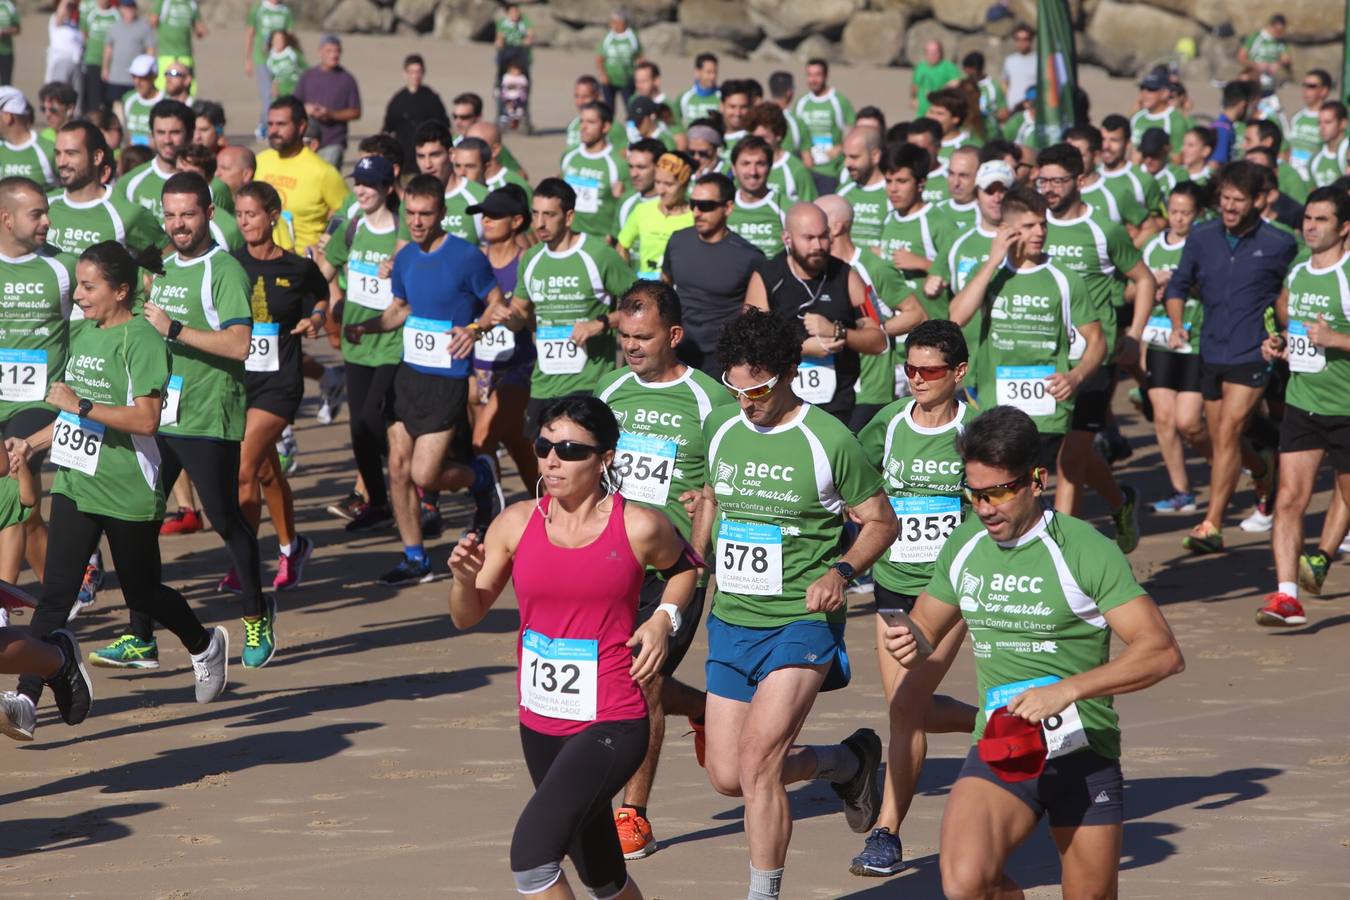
left=450, top=397, right=697, bottom=900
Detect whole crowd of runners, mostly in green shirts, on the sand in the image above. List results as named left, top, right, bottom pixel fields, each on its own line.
left=0, top=0, right=1350, bottom=900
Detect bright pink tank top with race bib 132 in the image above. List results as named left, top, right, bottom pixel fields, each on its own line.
left=513, top=494, right=647, bottom=735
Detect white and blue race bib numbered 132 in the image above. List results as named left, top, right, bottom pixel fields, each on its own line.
left=520, top=629, right=599, bottom=722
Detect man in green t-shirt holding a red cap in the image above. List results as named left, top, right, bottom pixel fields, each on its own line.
left=883, top=404, right=1185, bottom=897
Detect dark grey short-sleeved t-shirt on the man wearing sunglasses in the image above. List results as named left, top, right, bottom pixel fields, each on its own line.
left=662, top=228, right=764, bottom=378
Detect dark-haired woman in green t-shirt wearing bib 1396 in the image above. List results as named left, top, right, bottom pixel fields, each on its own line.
left=3, top=238, right=230, bottom=741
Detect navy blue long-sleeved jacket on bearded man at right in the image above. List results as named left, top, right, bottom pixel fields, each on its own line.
left=1166, top=221, right=1299, bottom=366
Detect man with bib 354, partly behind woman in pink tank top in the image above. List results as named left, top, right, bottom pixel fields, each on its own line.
left=595, top=282, right=734, bottom=860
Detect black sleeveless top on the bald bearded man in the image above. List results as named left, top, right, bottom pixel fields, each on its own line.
left=764, top=250, right=861, bottom=416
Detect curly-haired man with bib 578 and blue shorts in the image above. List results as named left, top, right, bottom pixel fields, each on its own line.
left=694, top=310, right=896, bottom=900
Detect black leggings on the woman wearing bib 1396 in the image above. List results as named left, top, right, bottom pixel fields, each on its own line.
left=19, top=494, right=211, bottom=703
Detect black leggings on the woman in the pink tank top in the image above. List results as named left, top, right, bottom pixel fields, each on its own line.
left=510, top=718, right=648, bottom=896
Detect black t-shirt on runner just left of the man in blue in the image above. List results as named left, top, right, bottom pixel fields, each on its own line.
left=235, top=247, right=328, bottom=390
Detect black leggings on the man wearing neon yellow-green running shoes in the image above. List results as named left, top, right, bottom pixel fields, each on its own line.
left=131, top=434, right=263, bottom=641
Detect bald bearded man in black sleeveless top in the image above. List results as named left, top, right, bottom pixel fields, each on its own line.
left=764, top=202, right=888, bottom=425
